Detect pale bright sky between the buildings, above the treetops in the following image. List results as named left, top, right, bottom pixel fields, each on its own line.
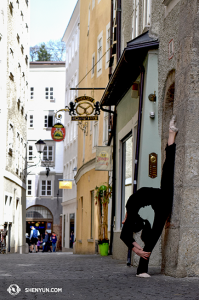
left=30, top=0, right=77, bottom=47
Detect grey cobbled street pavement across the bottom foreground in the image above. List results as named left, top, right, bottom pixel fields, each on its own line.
left=0, top=252, right=199, bottom=300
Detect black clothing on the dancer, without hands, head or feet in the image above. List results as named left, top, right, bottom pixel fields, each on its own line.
left=121, top=144, right=176, bottom=274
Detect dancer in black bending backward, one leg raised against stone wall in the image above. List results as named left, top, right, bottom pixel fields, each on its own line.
left=120, top=116, right=178, bottom=277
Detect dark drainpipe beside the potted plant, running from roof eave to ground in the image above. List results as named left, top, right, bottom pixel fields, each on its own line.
left=100, top=106, right=117, bottom=255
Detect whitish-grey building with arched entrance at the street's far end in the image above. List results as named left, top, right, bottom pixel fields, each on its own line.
left=26, top=62, right=65, bottom=249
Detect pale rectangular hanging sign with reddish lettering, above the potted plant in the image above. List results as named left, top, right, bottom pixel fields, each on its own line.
left=95, top=146, right=112, bottom=171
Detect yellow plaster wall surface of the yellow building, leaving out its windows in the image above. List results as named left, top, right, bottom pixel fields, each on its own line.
left=75, top=0, right=111, bottom=253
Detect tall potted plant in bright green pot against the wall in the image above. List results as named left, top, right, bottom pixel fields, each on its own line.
left=95, top=183, right=112, bottom=256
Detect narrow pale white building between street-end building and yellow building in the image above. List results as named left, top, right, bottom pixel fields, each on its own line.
left=60, top=0, right=80, bottom=251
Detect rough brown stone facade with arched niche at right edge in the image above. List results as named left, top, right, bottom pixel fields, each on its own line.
left=150, top=0, right=199, bottom=277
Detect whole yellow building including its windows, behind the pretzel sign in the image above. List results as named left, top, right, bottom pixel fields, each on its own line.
left=75, top=0, right=111, bottom=253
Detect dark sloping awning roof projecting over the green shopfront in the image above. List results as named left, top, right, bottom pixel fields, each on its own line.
left=100, top=31, right=159, bottom=106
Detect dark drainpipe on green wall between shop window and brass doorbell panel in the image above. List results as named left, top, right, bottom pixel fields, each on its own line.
left=127, top=66, right=144, bottom=266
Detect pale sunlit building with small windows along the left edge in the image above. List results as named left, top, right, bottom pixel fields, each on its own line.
left=0, top=1, right=29, bottom=253
